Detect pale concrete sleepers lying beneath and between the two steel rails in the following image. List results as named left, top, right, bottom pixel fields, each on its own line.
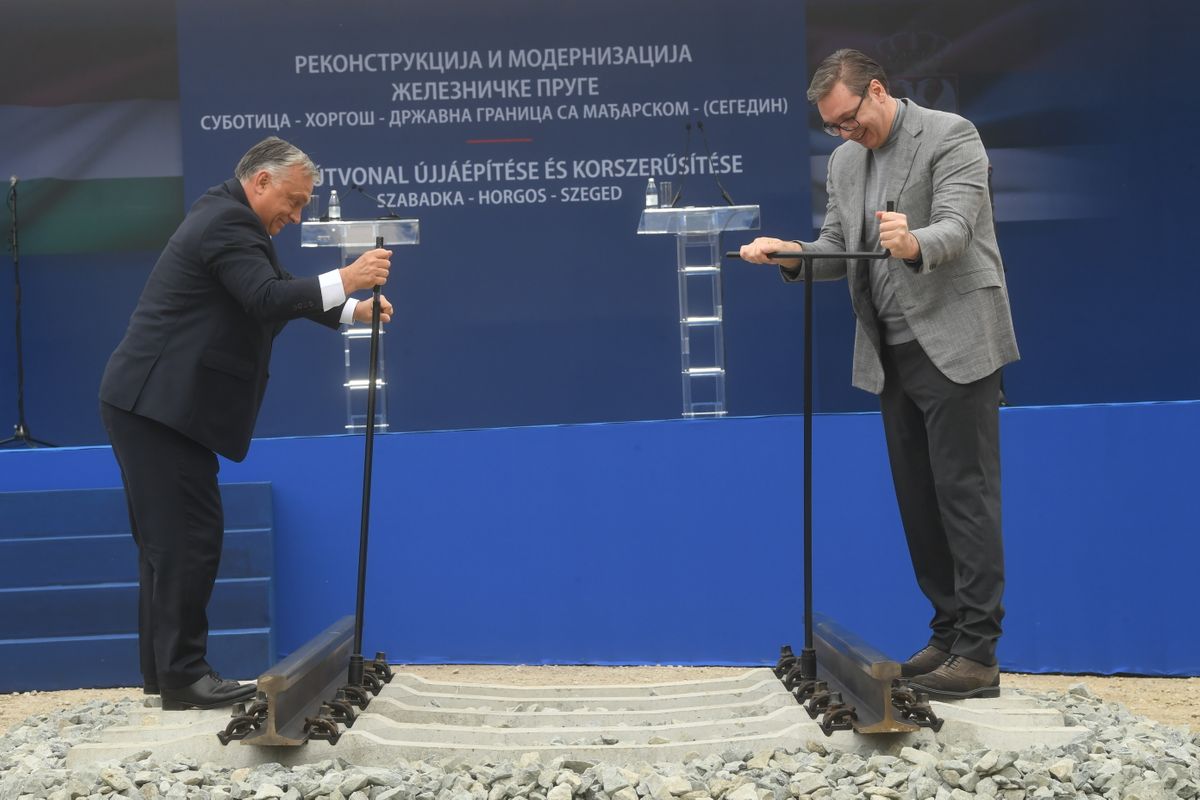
left=67, top=669, right=1087, bottom=768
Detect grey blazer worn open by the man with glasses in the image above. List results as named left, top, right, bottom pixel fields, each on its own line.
left=784, top=100, right=1020, bottom=395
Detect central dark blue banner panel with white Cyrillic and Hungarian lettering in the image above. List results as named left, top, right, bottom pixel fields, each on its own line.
left=179, top=0, right=816, bottom=429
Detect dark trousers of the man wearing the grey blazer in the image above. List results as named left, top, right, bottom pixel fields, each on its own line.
left=880, top=342, right=1004, bottom=664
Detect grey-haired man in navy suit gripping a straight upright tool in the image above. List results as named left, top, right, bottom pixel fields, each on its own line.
left=100, top=137, right=392, bottom=710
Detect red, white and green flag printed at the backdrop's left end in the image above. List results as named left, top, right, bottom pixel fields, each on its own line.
left=0, top=0, right=184, bottom=254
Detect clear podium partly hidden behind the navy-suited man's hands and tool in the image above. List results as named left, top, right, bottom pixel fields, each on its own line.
left=300, top=219, right=421, bottom=433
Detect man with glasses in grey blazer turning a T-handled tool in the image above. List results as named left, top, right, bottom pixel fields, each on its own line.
left=742, top=49, right=1020, bottom=697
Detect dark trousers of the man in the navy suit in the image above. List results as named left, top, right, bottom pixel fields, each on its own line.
left=100, top=403, right=224, bottom=688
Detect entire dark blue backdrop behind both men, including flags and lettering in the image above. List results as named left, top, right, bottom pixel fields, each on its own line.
left=0, top=0, right=1200, bottom=444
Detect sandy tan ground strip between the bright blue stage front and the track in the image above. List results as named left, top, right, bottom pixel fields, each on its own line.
left=0, top=664, right=1200, bottom=732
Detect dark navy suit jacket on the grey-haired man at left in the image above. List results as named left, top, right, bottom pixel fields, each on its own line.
left=100, top=179, right=342, bottom=461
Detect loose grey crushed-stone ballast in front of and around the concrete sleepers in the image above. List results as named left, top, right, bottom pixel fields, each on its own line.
left=0, top=684, right=1200, bottom=800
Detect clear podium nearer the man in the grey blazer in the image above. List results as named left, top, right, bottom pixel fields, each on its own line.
left=637, top=205, right=760, bottom=417
